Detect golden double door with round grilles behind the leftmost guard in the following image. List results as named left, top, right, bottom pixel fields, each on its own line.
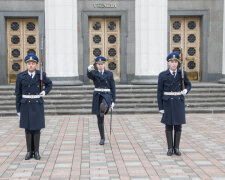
left=7, top=19, right=39, bottom=83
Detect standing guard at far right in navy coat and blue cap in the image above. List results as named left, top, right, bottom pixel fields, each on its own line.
left=157, top=53, right=191, bottom=156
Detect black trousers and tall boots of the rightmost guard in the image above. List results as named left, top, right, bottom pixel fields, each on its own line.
left=166, top=125, right=182, bottom=156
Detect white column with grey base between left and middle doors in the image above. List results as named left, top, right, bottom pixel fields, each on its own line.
left=45, top=0, right=82, bottom=85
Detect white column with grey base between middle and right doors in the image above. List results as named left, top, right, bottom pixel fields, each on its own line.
left=132, top=0, right=168, bottom=84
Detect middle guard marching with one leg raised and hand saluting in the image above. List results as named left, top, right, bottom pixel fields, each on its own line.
left=87, top=56, right=116, bottom=145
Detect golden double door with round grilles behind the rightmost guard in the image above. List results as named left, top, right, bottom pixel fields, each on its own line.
left=170, top=17, right=201, bottom=80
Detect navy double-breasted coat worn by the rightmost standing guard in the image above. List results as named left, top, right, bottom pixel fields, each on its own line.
left=157, top=69, right=191, bottom=125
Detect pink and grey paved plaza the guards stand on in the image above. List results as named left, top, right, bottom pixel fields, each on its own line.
left=0, top=114, right=225, bottom=180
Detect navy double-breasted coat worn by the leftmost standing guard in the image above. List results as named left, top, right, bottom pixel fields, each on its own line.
left=15, top=70, right=52, bottom=130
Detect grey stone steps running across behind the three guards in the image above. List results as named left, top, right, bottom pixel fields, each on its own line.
left=0, top=83, right=225, bottom=117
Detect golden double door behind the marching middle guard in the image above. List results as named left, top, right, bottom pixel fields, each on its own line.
left=89, top=18, right=120, bottom=82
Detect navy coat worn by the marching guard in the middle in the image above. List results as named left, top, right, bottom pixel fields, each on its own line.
left=87, top=70, right=116, bottom=115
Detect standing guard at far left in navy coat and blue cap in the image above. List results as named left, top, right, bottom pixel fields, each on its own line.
left=15, top=54, right=52, bottom=160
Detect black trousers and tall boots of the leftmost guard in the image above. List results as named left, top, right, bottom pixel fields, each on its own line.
left=25, top=129, right=41, bottom=160
